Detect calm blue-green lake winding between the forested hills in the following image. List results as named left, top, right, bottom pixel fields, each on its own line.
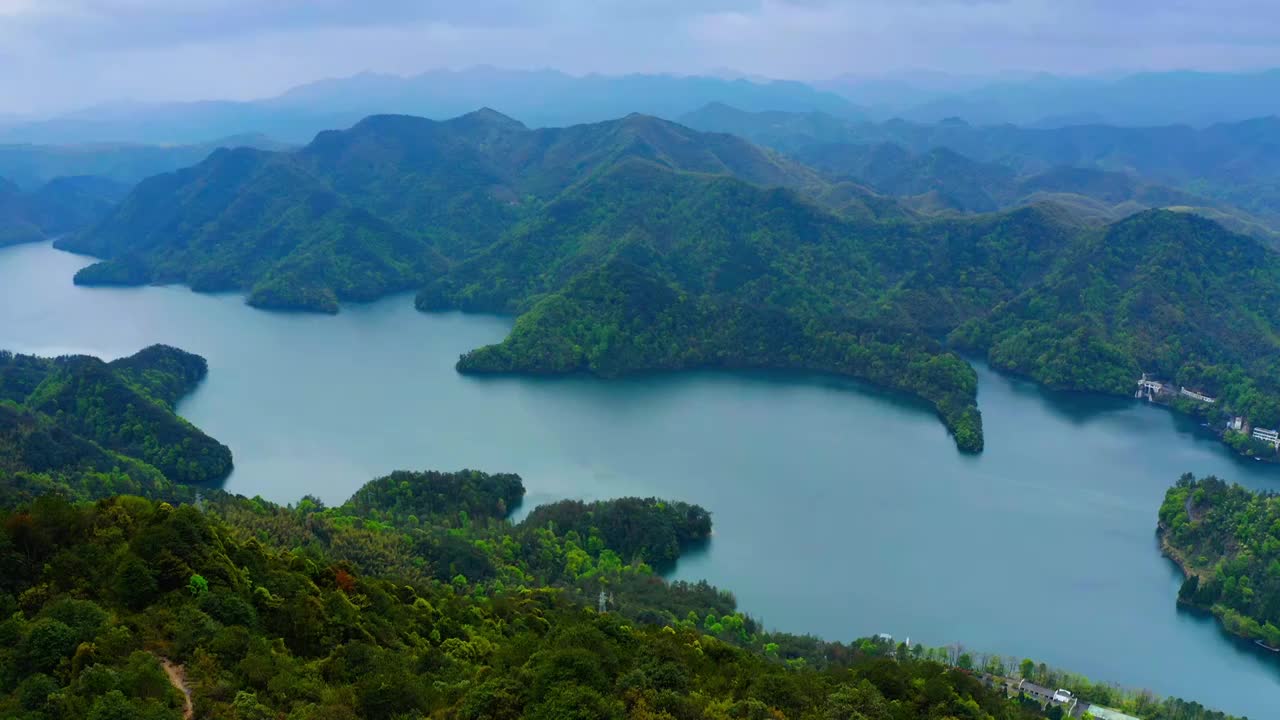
left=0, top=245, right=1280, bottom=719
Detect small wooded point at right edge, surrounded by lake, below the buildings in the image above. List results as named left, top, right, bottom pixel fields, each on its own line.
left=1160, top=474, right=1280, bottom=651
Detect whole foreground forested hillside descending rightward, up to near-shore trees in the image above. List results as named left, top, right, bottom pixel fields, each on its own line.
left=0, top=474, right=1046, bottom=720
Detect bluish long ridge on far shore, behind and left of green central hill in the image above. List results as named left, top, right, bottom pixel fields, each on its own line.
left=59, top=110, right=822, bottom=311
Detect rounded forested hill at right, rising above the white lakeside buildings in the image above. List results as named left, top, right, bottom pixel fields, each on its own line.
left=952, top=211, right=1280, bottom=427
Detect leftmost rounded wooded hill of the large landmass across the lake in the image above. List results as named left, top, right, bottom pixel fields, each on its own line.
left=59, top=149, right=443, bottom=311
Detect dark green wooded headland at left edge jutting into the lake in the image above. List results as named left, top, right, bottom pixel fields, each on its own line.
left=0, top=346, right=232, bottom=497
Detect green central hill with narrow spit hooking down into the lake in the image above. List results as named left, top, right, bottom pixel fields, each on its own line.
left=419, top=160, right=982, bottom=450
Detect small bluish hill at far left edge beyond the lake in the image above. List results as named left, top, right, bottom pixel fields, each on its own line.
left=0, top=176, right=128, bottom=247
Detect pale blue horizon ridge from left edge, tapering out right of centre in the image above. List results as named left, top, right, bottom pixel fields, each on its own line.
left=0, top=67, right=859, bottom=145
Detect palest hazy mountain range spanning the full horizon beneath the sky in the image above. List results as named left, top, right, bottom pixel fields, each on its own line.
left=0, top=67, right=1280, bottom=145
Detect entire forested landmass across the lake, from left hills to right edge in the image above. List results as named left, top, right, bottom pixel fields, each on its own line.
left=59, top=110, right=1280, bottom=455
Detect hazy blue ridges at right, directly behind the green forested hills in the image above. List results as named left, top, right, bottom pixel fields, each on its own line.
left=681, top=104, right=1280, bottom=240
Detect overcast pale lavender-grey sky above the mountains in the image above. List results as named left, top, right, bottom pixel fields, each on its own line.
left=0, top=0, right=1280, bottom=113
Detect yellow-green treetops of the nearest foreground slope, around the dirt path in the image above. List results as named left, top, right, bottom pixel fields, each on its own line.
left=0, top=489, right=1064, bottom=720
